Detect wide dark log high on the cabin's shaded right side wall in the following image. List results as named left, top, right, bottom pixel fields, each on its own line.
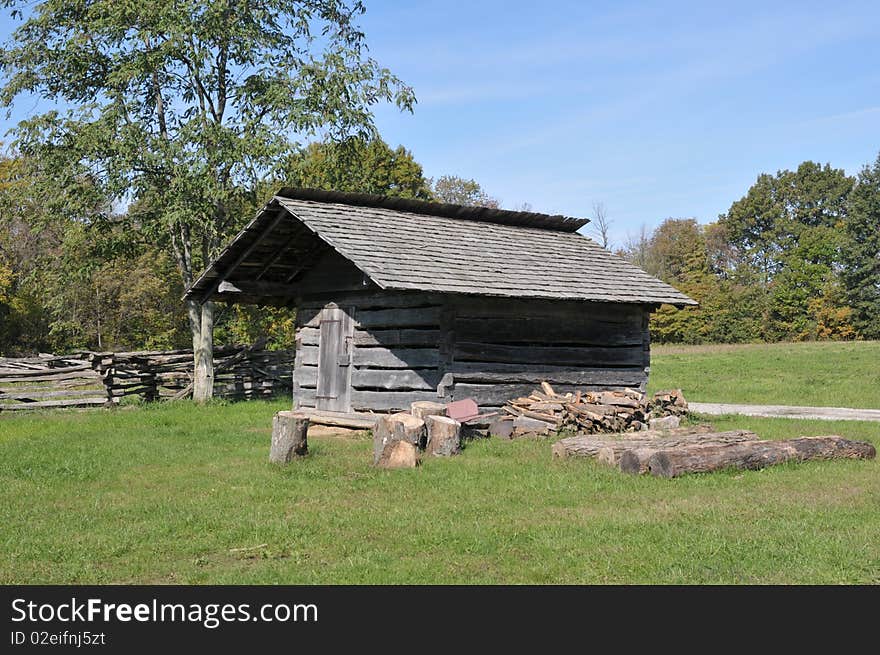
left=455, top=315, right=642, bottom=346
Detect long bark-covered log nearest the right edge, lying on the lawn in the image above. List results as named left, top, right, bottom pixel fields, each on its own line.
left=648, top=436, right=877, bottom=478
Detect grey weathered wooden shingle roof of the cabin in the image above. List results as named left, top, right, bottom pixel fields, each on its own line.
left=187, top=189, right=697, bottom=306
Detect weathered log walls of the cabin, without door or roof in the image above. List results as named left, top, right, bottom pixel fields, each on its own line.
left=294, top=288, right=650, bottom=411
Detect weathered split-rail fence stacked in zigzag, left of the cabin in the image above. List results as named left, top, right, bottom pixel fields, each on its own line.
left=0, top=343, right=294, bottom=411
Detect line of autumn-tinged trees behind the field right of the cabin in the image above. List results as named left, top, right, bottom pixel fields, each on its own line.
left=618, top=156, right=880, bottom=343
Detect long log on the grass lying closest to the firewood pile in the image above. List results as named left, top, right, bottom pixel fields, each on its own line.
left=552, top=428, right=760, bottom=464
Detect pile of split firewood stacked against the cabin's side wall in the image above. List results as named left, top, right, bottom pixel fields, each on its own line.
left=493, top=382, right=687, bottom=434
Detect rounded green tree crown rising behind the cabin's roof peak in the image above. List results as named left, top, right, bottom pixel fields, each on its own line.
left=283, top=137, right=432, bottom=200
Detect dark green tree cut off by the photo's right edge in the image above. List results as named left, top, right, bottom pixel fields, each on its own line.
left=842, top=155, right=880, bottom=339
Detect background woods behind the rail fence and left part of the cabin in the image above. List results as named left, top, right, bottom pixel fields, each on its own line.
left=0, top=138, right=500, bottom=355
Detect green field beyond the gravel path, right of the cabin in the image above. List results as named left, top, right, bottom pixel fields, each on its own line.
left=650, top=341, right=880, bottom=409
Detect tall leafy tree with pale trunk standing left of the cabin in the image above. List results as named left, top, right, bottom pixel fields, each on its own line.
left=0, top=0, right=415, bottom=400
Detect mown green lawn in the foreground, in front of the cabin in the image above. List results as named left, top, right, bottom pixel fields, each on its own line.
left=0, top=401, right=880, bottom=584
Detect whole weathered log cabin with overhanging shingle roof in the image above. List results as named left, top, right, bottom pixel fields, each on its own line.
left=187, top=189, right=696, bottom=413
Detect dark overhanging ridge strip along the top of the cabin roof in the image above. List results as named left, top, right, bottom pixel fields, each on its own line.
left=275, top=187, right=590, bottom=232
